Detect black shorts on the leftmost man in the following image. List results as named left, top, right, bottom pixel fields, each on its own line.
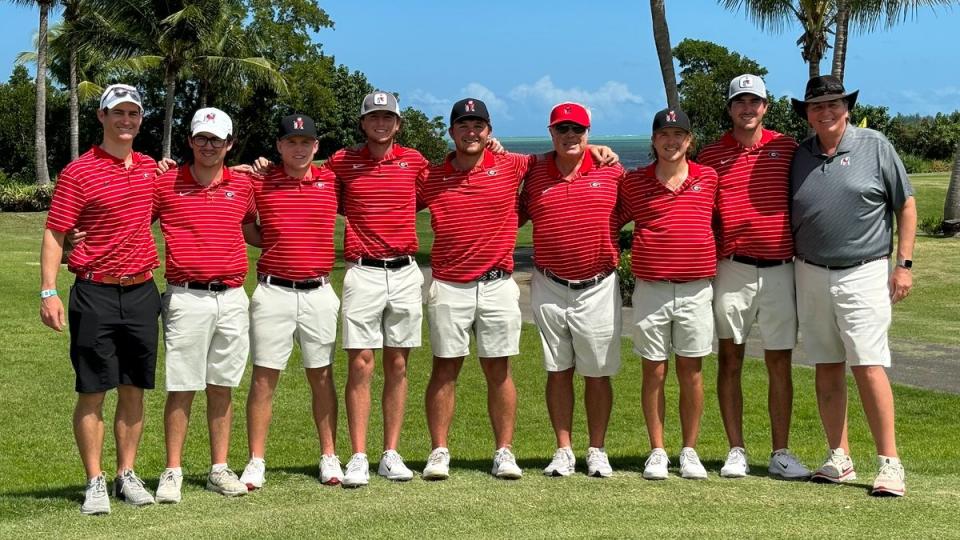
left=68, top=279, right=160, bottom=393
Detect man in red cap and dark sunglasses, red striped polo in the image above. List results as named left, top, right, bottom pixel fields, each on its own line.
left=520, top=103, right=624, bottom=477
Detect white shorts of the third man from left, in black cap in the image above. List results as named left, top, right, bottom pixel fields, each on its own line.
left=250, top=283, right=340, bottom=370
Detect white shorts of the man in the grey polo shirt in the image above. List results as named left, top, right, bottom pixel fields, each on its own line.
left=797, top=259, right=891, bottom=367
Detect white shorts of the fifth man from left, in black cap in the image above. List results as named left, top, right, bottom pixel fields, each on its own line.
left=427, top=277, right=520, bottom=358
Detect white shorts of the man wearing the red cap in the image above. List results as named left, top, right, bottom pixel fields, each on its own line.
left=530, top=270, right=622, bottom=377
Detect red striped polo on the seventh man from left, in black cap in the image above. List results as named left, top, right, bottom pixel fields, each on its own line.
left=620, top=161, right=717, bottom=282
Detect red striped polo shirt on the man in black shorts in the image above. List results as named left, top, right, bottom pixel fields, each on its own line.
left=46, top=146, right=160, bottom=277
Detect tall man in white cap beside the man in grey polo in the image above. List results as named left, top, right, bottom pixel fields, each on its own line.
left=697, top=74, right=810, bottom=478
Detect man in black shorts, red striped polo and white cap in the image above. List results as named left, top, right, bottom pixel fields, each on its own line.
left=40, top=84, right=160, bottom=514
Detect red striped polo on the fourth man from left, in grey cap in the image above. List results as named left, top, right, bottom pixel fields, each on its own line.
left=325, top=144, right=428, bottom=261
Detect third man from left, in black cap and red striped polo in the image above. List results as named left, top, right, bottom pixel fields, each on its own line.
left=240, top=114, right=343, bottom=490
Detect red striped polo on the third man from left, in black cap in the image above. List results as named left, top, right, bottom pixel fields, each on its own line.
left=254, top=165, right=337, bottom=280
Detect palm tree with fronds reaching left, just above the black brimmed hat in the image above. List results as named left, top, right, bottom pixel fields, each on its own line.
left=718, top=0, right=837, bottom=78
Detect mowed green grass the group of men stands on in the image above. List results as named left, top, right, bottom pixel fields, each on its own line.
left=0, top=172, right=960, bottom=538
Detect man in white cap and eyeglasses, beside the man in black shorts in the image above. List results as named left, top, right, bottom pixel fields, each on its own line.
left=153, top=108, right=256, bottom=503
